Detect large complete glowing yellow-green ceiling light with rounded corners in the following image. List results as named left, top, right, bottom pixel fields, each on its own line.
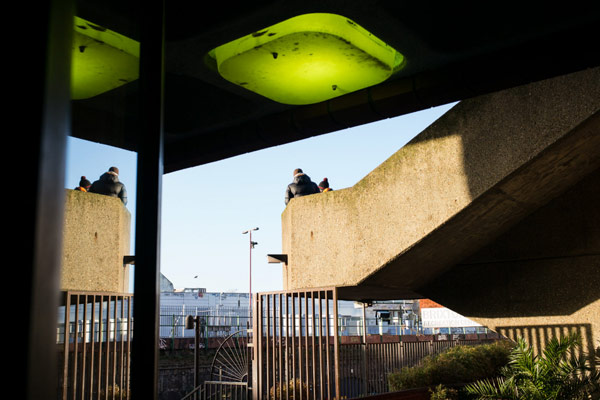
left=210, top=13, right=404, bottom=105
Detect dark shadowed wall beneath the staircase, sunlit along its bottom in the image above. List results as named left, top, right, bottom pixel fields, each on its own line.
left=422, top=170, right=600, bottom=352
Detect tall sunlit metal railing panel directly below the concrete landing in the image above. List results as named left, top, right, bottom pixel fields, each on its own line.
left=252, top=288, right=340, bottom=400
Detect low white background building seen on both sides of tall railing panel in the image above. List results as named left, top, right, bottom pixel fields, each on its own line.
left=160, top=276, right=486, bottom=338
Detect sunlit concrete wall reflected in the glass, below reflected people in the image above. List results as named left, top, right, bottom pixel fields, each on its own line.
left=61, top=190, right=131, bottom=293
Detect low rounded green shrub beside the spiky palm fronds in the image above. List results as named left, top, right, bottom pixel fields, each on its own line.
left=388, top=341, right=514, bottom=391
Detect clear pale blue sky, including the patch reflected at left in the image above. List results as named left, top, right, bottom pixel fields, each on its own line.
left=66, top=103, right=455, bottom=292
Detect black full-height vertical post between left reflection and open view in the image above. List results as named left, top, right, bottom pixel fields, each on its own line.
left=131, top=0, right=165, bottom=400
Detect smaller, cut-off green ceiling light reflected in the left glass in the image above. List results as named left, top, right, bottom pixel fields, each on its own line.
left=71, top=17, right=140, bottom=100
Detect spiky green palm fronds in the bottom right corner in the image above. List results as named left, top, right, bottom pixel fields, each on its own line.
left=465, top=335, right=600, bottom=400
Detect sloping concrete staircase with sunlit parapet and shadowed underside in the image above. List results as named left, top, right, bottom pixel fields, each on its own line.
left=282, top=68, right=600, bottom=300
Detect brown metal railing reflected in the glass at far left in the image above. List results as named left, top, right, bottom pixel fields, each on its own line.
left=57, top=292, right=133, bottom=400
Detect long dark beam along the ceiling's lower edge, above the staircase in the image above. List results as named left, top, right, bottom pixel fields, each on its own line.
left=165, top=48, right=600, bottom=173
